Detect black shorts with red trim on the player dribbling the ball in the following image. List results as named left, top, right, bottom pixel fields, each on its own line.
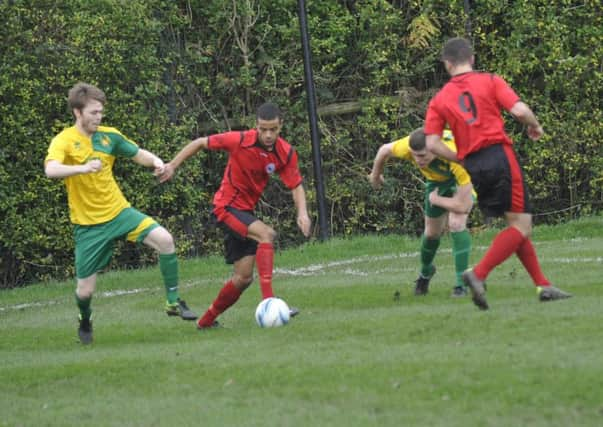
left=212, top=206, right=258, bottom=264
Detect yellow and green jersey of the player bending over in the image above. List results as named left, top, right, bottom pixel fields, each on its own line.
left=392, top=130, right=471, bottom=185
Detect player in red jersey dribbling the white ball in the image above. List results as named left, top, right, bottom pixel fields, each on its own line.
left=160, top=103, right=311, bottom=329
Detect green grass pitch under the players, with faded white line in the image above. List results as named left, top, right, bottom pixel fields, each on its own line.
left=0, top=217, right=603, bottom=427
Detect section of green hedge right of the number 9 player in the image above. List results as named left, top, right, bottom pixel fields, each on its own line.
left=475, top=0, right=603, bottom=219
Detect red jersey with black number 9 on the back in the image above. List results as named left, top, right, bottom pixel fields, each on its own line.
left=425, top=71, right=519, bottom=160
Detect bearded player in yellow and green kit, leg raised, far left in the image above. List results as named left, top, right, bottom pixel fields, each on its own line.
left=44, top=83, right=197, bottom=344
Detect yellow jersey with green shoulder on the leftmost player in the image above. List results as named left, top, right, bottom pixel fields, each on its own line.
left=44, top=126, right=138, bottom=225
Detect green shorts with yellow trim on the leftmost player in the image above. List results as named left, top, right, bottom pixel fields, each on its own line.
left=73, top=208, right=159, bottom=279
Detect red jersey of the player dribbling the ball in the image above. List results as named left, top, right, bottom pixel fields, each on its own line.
left=207, top=129, right=302, bottom=211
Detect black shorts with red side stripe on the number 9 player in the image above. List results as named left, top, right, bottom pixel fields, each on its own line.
left=463, top=144, right=532, bottom=217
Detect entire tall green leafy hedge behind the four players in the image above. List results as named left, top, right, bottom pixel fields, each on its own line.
left=0, top=0, right=603, bottom=287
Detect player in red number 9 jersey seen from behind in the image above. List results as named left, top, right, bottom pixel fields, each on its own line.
left=425, top=38, right=571, bottom=310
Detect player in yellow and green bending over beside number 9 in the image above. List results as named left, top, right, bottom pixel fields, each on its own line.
left=369, top=129, right=474, bottom=297
